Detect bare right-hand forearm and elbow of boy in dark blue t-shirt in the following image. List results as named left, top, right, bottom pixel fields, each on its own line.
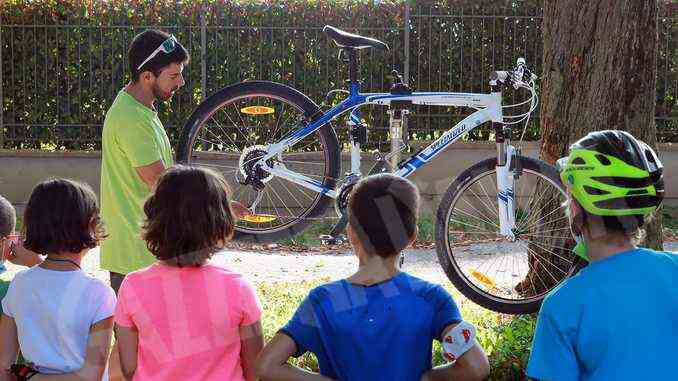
left=421, top=323, right=490, bottom=381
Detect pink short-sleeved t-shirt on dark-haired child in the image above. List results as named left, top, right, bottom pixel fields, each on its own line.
left=115, top=263, right=261, bottom=381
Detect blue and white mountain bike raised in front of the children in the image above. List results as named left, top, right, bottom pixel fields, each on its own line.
left=177, top=26, right=576, bottom=314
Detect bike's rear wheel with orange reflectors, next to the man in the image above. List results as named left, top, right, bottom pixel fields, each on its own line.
left=177, top=81, right=340, bottom=242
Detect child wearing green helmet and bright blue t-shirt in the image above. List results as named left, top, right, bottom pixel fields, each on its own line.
left=527, top=131, right=678, bottom=381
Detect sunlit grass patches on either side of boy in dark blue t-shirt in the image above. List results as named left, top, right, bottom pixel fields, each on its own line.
left=257, top=279, right=535, bottom=381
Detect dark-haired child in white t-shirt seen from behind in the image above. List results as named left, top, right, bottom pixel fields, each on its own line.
left=0, top=179, right=115, bottom=381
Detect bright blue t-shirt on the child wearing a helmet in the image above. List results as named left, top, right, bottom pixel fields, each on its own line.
left=527, top=249, right=678, bottom=381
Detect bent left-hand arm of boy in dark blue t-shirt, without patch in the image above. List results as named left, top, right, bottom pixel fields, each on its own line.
left=255, top=333, right=332, bottom=381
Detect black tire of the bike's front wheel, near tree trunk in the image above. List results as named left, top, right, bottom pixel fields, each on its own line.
left=436, top=156, right=581, bottom=314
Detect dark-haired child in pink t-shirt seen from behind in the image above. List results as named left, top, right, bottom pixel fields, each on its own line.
left=115, top=166, right=263, bottom=381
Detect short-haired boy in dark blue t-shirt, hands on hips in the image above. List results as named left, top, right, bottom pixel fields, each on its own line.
left=257, top=174, right=489, bottom=381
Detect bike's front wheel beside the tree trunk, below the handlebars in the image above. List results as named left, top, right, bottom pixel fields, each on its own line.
left=436, top=157, right=577, bottom=314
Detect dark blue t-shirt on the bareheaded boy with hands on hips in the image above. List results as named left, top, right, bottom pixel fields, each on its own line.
left=281, top=273, right=461, bottom=381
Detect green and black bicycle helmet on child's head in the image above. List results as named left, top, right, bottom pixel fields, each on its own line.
left=556, top=130, right=664, bottom=216
